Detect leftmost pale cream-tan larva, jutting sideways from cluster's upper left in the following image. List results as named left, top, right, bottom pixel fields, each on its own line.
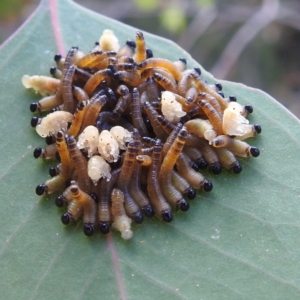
left=22, top=75, right=60, bottom=96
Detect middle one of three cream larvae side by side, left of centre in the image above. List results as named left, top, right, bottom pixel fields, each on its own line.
left=98, top=130, right=119, bottom=162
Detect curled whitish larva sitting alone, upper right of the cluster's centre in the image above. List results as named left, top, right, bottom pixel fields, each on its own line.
left=161, top=91, right=186, bottom=123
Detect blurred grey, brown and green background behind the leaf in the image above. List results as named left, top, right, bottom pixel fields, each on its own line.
left=0, top=0, right=300, bottom=118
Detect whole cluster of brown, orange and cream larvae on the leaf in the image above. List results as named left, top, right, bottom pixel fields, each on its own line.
left=22, top=30, right=261, bottom=239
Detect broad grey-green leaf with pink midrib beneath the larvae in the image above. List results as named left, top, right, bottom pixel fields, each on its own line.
left=0, top=1, right=300, bottom=300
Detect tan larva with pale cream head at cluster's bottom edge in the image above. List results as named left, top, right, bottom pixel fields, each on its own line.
left=111, top=189, right=133, bottom=240
